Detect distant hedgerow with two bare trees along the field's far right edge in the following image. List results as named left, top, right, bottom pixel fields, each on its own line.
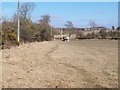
left=64, top=21, right=120, bottom=40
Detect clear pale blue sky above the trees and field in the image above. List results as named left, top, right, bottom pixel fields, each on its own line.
left=2, top=2, right=118, bottom=28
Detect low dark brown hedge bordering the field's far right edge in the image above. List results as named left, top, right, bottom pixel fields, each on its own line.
left=76, top=29, right=120, bottom=40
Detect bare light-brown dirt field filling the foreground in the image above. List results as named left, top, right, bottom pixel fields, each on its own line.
left=2, top=40, right=118, bottom=88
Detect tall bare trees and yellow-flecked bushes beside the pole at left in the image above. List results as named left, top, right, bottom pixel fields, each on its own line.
left=0, top=3, right=53, bottom=48
